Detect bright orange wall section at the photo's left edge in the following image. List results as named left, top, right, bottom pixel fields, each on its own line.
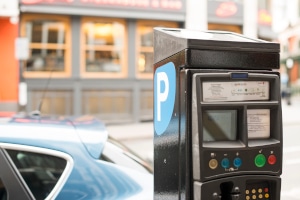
left=0, top=18, right=19, bottom=102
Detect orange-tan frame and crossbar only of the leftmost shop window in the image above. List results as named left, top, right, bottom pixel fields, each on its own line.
left=20, top=14, right=72, bottom=78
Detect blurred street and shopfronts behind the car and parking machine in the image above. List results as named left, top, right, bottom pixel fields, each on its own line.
left=0, top=0, right=300, bottom=200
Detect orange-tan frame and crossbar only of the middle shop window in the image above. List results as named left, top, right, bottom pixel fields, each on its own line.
left=80, top=17, right=128, bottom=79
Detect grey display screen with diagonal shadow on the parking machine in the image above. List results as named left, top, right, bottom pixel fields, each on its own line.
left=202, top=110, right=237, bottom=142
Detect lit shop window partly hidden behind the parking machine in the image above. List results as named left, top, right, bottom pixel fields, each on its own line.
left=136, top=21, right=178, bottom=79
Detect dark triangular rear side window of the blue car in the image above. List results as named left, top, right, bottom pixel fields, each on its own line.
left=5, top=150, right=67, bottom=200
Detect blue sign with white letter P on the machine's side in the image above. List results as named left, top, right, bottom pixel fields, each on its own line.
left=154, top=62, right=176, bottom=135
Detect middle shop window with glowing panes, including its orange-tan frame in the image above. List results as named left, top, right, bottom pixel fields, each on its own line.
left=81, top=18, right=127, bottom=78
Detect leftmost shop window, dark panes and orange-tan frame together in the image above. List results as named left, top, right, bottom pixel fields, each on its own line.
left=21, top=15, right=71, bottom=78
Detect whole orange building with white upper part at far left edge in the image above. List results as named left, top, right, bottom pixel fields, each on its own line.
left=0, top=0, right=19, bottom=115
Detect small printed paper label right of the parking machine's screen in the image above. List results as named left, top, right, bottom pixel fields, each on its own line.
left=247, top=109, right=270, bottom=139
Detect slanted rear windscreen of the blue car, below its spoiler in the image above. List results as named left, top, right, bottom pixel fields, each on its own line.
left=100, top=138, right=152, bottom=173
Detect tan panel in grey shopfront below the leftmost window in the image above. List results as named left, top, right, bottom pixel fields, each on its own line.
left=29, top=90, right=73, bottom=116
